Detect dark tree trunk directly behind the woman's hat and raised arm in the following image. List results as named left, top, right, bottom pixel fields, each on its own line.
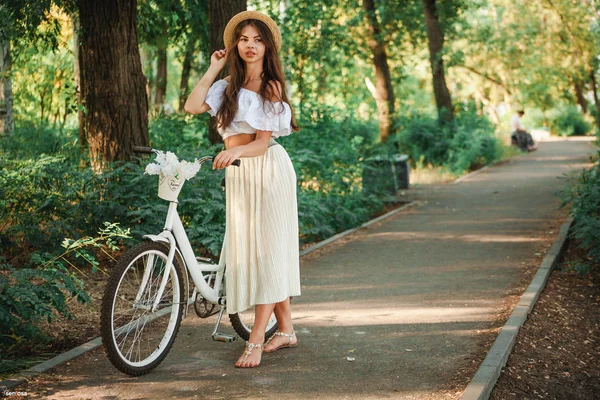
left=208, top=0, right=246, bottom=144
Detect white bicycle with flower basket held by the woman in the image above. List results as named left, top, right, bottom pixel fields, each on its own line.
left=101, top=146, right=277, bottom=376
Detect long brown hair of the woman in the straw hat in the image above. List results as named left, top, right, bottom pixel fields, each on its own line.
left=217, top=19, right=299, bottom=131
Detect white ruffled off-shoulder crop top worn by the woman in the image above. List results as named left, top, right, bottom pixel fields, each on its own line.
left=204, top=79, right=292, bottom=139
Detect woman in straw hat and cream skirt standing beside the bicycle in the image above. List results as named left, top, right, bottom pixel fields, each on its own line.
left=185, top=11, right=300, bottom=368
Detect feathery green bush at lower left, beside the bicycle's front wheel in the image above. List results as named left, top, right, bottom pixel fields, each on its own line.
left=0, top=223, right=129, bottom=353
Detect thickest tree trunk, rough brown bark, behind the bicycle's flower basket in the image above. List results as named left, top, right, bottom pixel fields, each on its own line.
left=79, top=0, right=149, bottom=170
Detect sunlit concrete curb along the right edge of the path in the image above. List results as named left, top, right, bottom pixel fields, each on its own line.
left=461, top=217, right=573, bottom=400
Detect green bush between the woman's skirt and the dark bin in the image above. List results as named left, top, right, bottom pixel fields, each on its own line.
left=279, top=106, right=385, bottom=243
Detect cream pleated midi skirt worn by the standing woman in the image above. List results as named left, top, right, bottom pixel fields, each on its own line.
left=220, top=144, right=300, bottom=314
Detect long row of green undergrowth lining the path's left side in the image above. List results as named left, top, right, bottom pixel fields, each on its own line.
left=0, top=107, right=496, bottom=356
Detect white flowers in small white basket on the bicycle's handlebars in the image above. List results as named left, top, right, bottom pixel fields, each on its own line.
left=145, top=151, right=200, bottom=201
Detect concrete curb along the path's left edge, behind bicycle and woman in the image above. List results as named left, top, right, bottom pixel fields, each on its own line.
left=0, top=201, right=418, bottom=390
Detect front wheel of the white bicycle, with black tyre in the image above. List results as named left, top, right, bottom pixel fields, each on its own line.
left=101, top=242, right=187, bottom=376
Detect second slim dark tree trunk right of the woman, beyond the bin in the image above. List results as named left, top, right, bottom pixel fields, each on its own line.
left=423, top=0, right=454, bottom=122
